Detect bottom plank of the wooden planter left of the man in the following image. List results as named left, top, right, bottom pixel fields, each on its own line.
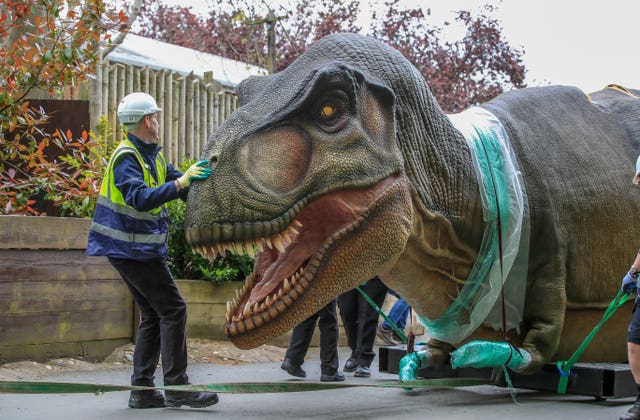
left=0, top=305, right=133, bottom=347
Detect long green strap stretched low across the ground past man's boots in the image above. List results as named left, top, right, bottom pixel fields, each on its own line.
left=0, top=378, right=493, bottom=395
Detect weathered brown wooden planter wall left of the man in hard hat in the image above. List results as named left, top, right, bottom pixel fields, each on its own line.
left=0, top=216, right=134, bottom=364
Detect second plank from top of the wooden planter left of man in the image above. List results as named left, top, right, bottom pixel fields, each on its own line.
left=0, top=250, right=120, bottom=285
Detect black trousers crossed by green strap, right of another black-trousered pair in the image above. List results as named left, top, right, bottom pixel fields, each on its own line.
left=338, top=276, right=388, bottom=367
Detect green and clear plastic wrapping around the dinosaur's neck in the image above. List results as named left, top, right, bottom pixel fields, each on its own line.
left=418, top=107, right=529, bottom=345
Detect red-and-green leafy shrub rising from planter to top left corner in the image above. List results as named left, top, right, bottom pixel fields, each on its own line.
left=0, top=0, right=128, bottom=217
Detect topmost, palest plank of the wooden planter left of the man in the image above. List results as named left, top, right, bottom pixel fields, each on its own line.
left=0, top=216, right=91, bottom=249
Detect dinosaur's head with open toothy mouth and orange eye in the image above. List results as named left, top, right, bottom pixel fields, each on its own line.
left=185, top=41, right=413, bottom=348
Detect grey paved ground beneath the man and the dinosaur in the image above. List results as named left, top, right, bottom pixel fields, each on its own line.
left=0, top=349, right=633, bottom=420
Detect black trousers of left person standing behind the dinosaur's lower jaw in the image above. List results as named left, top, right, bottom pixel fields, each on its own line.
left=285, top=300, right=339, bottom=375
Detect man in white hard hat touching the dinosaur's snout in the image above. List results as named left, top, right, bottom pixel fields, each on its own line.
left=87, top=92, right=218, bottom=408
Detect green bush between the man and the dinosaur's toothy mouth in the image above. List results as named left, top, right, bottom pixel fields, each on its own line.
left=165, top=159, right=253, bottom=283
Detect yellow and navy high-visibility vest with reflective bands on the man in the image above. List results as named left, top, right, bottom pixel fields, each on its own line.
left=87, top=139, right=169, bottom=261
